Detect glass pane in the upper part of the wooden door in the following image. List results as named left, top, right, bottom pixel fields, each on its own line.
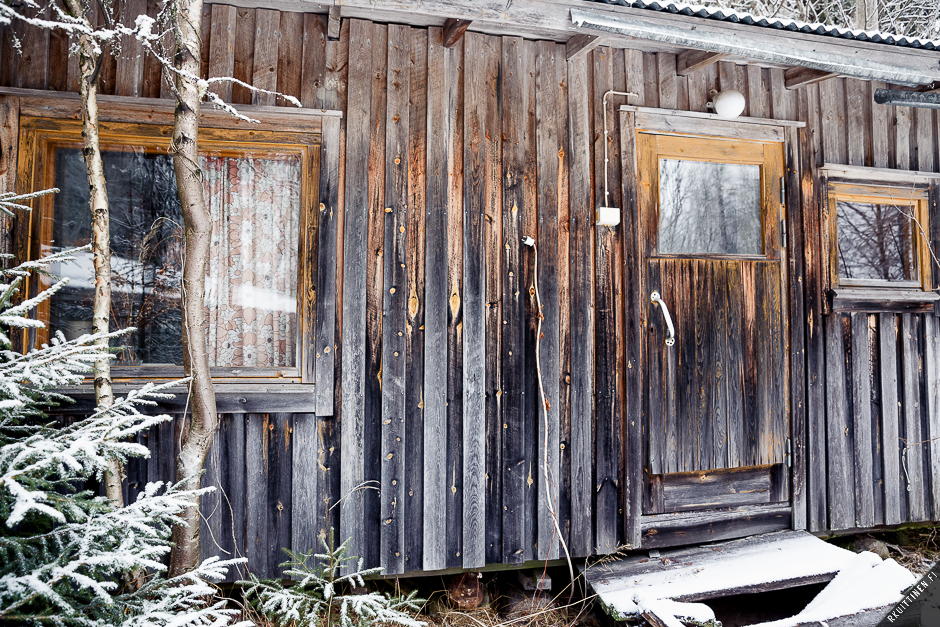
left=659, top=159, right=762, bottom=255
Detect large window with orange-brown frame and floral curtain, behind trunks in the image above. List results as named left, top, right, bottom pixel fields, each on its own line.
left=17, top=118, right=320, bottom=381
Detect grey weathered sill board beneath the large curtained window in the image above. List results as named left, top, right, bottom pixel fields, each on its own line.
left=49, top=381, right=320, bottom=418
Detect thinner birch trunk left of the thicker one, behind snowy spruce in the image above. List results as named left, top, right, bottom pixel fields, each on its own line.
left=67, top=0, right=124, bottom=508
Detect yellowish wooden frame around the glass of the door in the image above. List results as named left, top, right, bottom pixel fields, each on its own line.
left=636, top=127, right=786, bottom=260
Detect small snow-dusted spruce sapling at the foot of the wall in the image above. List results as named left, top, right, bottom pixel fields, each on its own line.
left=238, top=530, right=425, bottom=627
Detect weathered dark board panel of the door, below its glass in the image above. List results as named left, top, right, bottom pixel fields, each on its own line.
left=648, top=258, right=787, bottom=474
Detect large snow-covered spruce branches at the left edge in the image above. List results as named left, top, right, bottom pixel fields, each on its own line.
left=0, top=251, right=250, bottom=627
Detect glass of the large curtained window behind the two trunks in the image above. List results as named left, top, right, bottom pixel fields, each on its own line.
left=50, top=149, right=301, bottom=367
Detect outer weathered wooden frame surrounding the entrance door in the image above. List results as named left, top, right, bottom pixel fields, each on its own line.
left=619, top=105, right=812, bottom=547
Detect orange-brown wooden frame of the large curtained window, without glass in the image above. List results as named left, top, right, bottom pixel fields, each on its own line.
left=14, top=116, right=321, bottom=383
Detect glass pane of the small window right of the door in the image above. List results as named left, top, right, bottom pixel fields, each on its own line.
left=836, top=201, right=917, bottom=281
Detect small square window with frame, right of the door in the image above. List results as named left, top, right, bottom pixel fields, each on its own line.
left=821, top=165, right=938, bottom=310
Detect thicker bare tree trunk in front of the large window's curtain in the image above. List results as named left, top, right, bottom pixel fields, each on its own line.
left=169, top=0, right=218, bottom=577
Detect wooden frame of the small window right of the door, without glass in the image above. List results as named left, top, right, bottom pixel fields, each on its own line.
left=819, top=164, right=940, bottom=313
